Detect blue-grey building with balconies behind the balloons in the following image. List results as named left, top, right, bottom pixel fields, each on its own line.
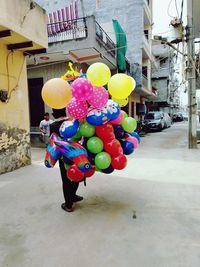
left=28, top=0, right=156, bottom=121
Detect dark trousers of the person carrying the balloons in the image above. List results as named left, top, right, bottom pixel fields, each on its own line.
left=59, top=160, right=79, bottom=208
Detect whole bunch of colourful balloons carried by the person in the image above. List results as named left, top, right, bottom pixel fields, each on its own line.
left=42, top=63, right=140, bottom=181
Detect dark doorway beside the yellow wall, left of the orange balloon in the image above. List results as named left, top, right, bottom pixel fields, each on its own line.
left=28, top=78, right=45, bottom=127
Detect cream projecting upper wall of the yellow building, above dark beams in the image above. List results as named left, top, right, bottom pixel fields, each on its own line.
left=0, top=0, right=47, bottom=48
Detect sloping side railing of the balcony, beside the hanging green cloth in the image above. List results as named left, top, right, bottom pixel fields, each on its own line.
left=95, top=22, right=116, bottom=57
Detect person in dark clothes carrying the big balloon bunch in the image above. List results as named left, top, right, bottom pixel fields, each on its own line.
left=50, top=109, right=83, bottom=212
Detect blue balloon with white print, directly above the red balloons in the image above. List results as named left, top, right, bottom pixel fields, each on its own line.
left=86, top=108, right=111, bottom=126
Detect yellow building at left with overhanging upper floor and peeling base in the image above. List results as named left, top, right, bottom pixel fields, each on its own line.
left=0, top=0, right=47, bottom=174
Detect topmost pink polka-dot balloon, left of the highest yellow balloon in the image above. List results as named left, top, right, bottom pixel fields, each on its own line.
left=71, top=78, right=93, bottom=101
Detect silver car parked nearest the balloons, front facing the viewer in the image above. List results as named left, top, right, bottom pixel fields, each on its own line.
left=145, top=111, right=165, bottom=131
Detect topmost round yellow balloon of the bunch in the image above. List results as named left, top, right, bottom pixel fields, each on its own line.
left=86, top=62, right=111, bottom=87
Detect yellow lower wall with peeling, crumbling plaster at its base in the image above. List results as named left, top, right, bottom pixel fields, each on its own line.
left=0, top=43, right=31, bottom=174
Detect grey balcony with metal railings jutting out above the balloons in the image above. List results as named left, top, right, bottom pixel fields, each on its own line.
left=44, top=16, right=116, bottom=70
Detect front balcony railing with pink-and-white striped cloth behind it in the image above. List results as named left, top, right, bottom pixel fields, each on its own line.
left=47, top=18, right=87, bottom=43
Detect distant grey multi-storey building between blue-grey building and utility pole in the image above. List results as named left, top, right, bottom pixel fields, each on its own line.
left=149, top=41, right=180, bottom=114
